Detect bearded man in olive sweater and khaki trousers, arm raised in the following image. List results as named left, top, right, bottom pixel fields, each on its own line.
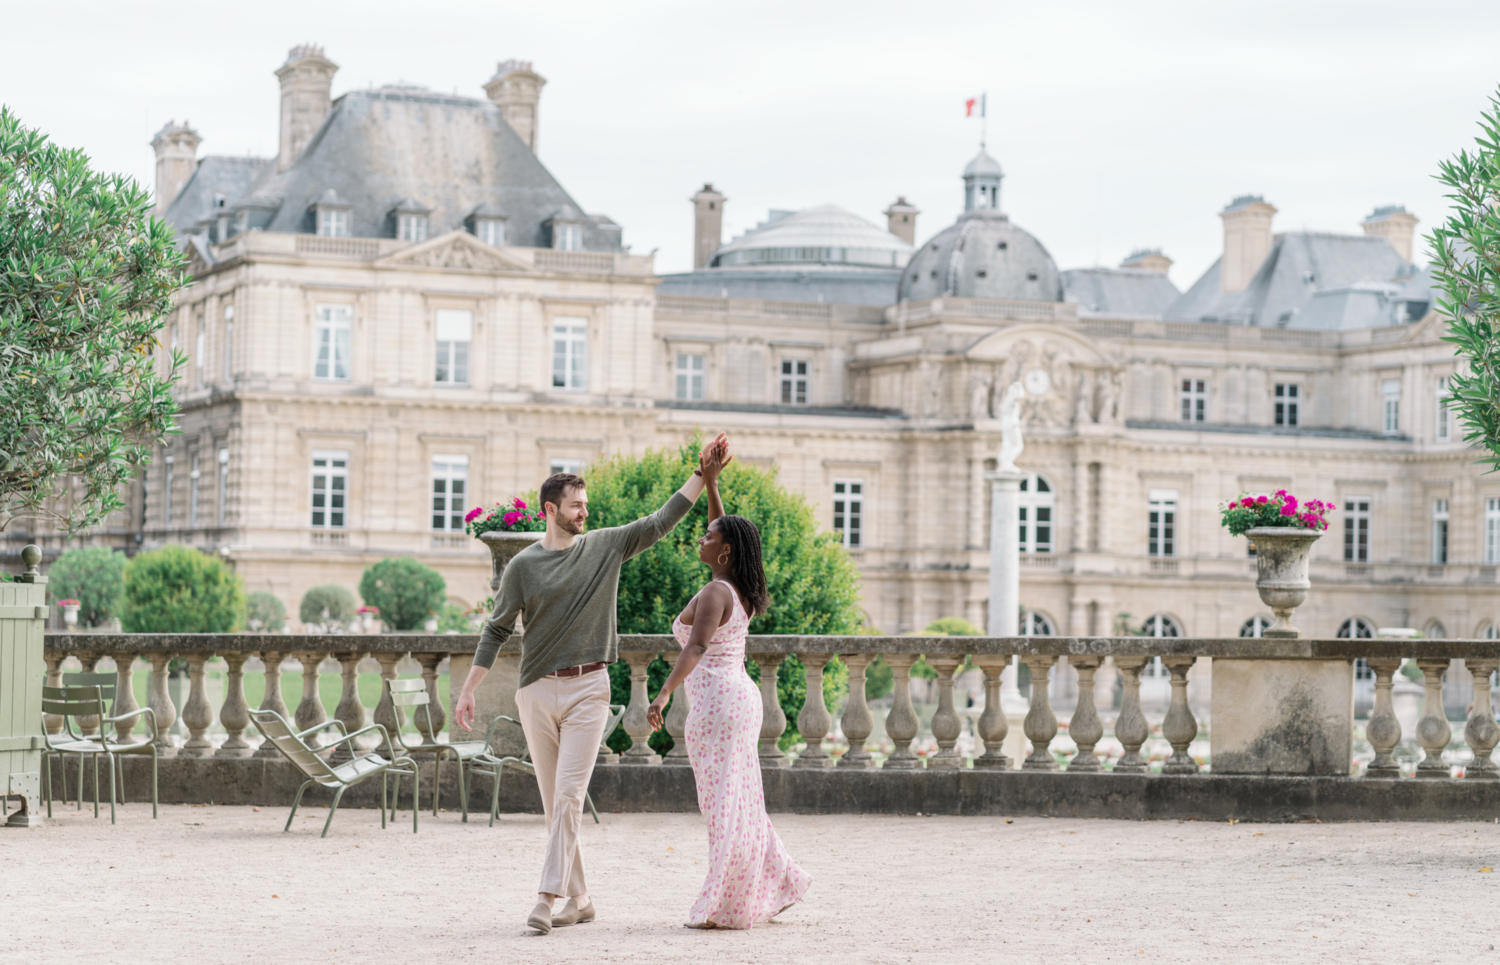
left=453, top=434, right=728, bottom=935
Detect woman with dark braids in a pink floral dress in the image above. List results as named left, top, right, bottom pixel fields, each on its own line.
left=647, top=443, right=813, bottom=927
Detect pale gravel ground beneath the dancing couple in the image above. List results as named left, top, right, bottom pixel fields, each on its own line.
left=0, top=804, right=1500, bottom=965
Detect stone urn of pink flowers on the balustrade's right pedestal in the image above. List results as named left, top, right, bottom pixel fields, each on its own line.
left=1220, top=489, right=1335, bottom=636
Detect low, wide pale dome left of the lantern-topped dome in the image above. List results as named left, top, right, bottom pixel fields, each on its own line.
left=710, top=204, right=912, bottom=270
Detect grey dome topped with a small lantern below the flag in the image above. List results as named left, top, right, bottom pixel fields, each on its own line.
left=897, top=149, right=1062, bottom=302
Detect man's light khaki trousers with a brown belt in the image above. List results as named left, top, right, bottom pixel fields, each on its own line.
left=516, top=669, right=609, bottom=897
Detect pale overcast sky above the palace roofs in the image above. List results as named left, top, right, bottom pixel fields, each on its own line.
left=0, top=0, right=1500, bottom=288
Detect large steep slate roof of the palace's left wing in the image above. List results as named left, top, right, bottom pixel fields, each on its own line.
left=167, top=87, right=621, bottom=251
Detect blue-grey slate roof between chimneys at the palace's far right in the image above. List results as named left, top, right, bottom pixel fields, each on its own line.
left=1164, top=231, right=1431, bottom=330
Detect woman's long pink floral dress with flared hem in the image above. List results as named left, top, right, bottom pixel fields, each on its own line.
left=672, top=581, right=813, bottom=927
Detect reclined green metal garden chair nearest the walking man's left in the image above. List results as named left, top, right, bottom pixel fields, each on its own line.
left=251, top=710, right=422, bottom=837
